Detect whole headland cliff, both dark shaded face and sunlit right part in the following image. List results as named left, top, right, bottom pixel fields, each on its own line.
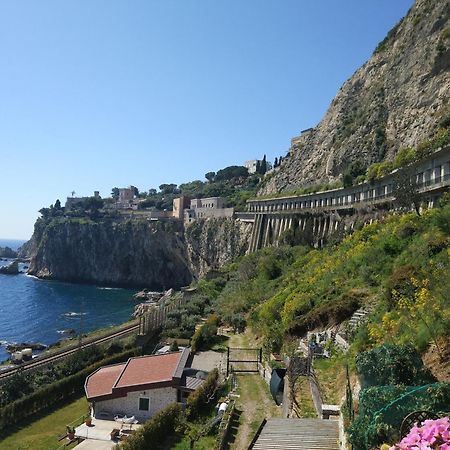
left=28, top=218, right=251, bottom=290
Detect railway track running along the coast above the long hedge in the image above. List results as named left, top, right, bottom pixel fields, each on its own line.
left=0, top=322, right=139, bottom=383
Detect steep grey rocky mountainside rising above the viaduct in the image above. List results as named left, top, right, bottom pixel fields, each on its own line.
left=260, top=0, right=450, bottom=194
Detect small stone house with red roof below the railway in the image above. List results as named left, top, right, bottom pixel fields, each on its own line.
left=85, top=349, right=203, bottom=422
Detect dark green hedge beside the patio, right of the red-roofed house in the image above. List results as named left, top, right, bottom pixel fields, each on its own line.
left=120, top=403, right=182, bottom=450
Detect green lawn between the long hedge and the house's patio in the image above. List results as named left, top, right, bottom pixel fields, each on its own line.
left=0, top=397, right=88, bottom=450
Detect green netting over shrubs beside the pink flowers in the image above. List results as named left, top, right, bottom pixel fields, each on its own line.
left=348, top=383, right=450, bottom=450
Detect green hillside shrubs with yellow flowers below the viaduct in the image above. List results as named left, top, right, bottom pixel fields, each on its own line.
left=184, top=196, right=450, bottom=358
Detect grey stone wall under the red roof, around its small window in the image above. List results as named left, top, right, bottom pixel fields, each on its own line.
left=94, top=387, right=177, bottom=422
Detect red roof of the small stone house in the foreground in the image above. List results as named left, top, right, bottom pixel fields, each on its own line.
left=85, top=350, right=189, bottom=400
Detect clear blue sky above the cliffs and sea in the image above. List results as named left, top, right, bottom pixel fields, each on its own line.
left=0, top=0, right=413, bottom=238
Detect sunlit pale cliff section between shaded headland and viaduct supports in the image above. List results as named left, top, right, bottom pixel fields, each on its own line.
left=185, top=219, right=252, bottom=278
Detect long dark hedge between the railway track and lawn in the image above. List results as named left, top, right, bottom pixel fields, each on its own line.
left=0, top=349, right=136, bottom=432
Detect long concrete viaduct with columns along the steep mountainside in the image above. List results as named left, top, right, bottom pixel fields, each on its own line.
left=236, top=146, right=450, bottom=253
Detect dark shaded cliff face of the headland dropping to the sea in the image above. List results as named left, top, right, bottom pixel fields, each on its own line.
left=29, top=220, right=192, bottom=289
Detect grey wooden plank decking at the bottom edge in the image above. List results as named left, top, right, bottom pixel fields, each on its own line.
left=249, top=419, right=339, bottom=450
